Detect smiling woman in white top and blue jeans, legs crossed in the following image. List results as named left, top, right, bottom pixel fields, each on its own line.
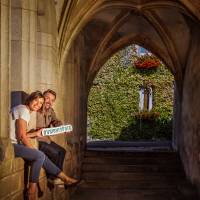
left=10, top=91, right=78, bottom=200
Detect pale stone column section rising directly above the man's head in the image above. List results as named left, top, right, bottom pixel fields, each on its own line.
left=35, top=0, right=59, bottom=90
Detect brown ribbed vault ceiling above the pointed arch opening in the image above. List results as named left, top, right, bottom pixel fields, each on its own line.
left=55, top=0, right=200, bottom=90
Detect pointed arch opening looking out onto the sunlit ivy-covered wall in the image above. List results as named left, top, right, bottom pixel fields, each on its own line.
left=87, top=44, right=174, bottom=151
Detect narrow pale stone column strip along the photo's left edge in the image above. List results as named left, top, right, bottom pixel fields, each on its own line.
left=0, top=0, right=13, bottom=178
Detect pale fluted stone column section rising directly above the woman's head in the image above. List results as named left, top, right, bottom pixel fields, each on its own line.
left=11, top=0, right=37, bottom=93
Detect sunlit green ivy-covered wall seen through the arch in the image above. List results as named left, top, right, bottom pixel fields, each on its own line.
left=88, top=47, right=174, bottom=141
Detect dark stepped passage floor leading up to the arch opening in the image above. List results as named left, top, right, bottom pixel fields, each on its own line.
left=72, top=142, right=199, bottom=200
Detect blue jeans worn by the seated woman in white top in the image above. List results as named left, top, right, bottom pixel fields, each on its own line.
left=13, top=144, right=61, bottom=183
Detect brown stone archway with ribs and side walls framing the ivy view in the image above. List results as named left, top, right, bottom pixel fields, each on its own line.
left=59, top=1, right=200, bottom=191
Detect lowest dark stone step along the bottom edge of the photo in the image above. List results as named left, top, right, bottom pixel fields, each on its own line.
left=72, top=181, right=199, bottom=200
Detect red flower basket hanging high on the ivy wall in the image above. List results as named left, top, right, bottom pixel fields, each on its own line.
left=133, top=55, right=161, bottom=69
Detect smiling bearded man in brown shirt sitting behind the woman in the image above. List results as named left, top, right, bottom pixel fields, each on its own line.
left=36, top=89, right=66, bottom=184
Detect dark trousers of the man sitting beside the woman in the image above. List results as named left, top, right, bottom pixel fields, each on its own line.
left=39, top=142, right=66, bottom=179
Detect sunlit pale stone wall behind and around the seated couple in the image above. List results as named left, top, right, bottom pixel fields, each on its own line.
left=0, top=0, right=80, bottom=200
